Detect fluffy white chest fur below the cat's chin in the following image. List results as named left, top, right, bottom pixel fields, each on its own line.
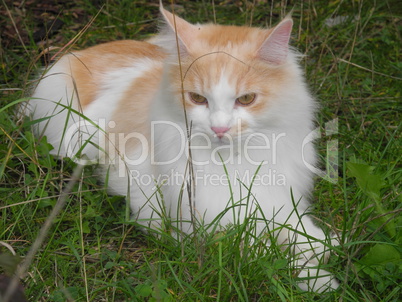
left=146, top=105, right=312, bottom=219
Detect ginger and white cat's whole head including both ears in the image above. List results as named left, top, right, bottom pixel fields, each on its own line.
left=153, top=8, right=311, bottom=143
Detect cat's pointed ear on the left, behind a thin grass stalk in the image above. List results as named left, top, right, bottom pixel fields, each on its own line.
left=160, top=6, right=197, bottom=55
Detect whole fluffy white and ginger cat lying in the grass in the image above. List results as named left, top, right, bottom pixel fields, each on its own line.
left=28, top=7, right=338, bottom=292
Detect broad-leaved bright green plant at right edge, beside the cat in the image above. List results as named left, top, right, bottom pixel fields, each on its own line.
left=347, top=162, right=402, bottom=293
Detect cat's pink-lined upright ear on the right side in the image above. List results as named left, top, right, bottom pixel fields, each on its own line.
left=258, top=17, right=293, bottom=65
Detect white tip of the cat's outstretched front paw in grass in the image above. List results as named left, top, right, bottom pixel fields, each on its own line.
left=297, top=265, right=339, bottom=293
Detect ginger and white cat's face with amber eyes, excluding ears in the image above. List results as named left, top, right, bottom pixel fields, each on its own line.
left=170, top=52, right=288, bottom=144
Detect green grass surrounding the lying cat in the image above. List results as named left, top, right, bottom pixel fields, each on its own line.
left=0, top=0, right=402, bottom=301
